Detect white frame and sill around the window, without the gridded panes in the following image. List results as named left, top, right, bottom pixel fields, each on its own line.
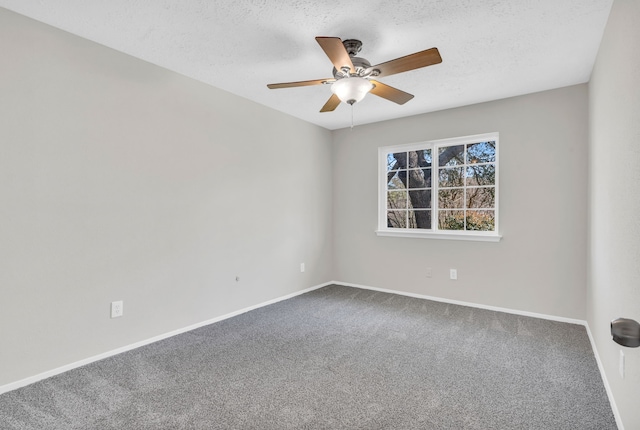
left=376, top=132, right=502, bottom=242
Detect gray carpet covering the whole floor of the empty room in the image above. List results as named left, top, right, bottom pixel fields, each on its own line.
left=0, top=286, right=616, bottom=430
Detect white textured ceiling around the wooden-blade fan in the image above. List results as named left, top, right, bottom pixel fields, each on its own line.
left=0, top=0, right=613, bottom=129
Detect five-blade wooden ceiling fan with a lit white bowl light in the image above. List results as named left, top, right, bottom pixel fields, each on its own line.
left=267, top=37, right=442, bottom=112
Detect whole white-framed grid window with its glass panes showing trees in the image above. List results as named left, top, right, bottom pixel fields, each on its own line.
left=377, top=133, right=500, bottom=241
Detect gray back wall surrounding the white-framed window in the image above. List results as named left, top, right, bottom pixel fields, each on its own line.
left=333, top=85, right=588, bottom=319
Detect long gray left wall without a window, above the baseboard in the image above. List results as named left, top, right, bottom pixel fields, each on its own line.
left=0, top=8, right=332, bottom=386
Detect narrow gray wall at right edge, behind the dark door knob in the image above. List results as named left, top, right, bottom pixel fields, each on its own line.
left=587, top=0, right=640, bottom=429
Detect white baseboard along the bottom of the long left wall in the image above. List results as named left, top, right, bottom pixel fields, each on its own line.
left=0, top=282, right=332, bottom=394
